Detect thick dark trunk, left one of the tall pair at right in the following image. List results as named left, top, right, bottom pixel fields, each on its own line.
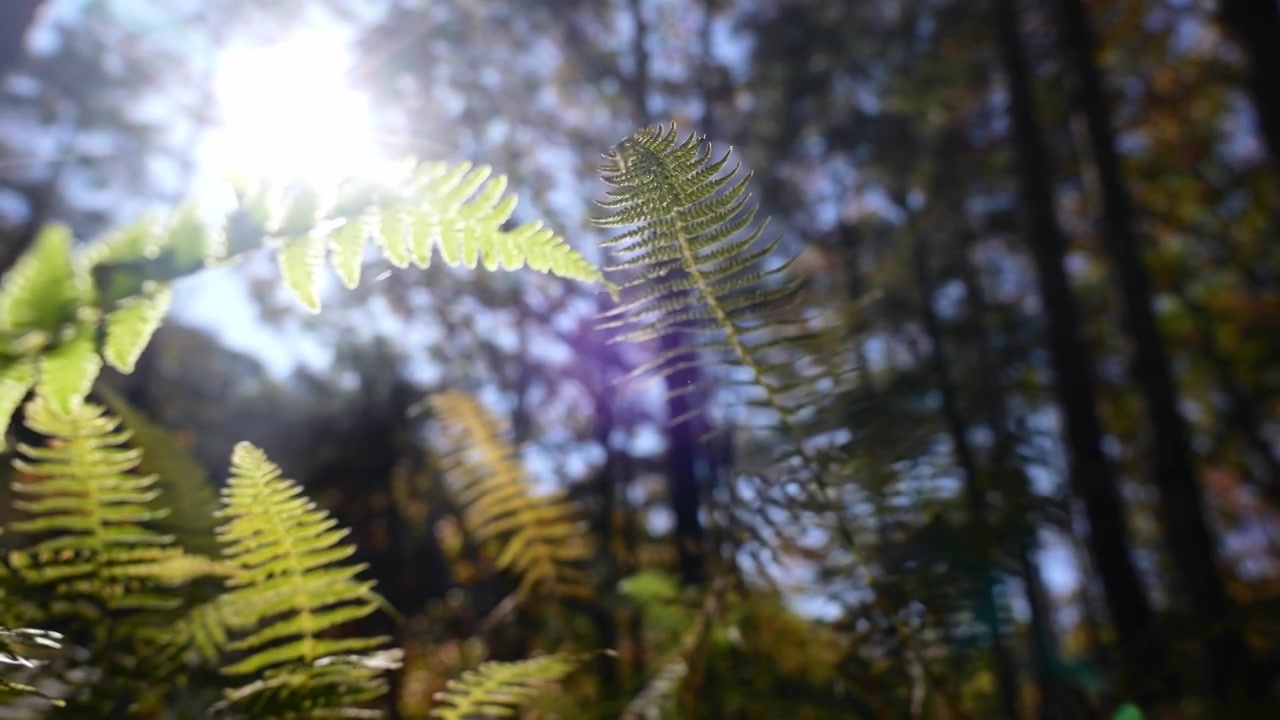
left=995, top=0, right=1160, bottom=702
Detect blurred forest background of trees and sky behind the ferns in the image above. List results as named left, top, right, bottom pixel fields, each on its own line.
left=0, top=0, right=1280, bottom=717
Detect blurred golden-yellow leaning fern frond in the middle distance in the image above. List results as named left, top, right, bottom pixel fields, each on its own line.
left=430, top=391, right=591, bottom=598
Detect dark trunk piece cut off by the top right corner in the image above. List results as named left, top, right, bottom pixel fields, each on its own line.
left=1219, top=0, right=1280, bottom=173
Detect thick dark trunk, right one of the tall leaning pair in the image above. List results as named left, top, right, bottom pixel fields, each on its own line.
left=1059, top=0, right=1259, bottom=700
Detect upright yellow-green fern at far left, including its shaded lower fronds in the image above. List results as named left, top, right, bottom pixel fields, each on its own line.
left=6, top=396, right=230, bottom=714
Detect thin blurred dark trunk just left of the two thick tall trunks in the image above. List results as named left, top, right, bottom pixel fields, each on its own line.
left=913, top=232, right=1021, bottom=720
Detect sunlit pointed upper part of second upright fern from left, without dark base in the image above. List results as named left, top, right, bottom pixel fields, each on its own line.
left=218, top=442, right=387, bottom=684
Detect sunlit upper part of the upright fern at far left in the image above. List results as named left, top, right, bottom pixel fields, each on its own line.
left=3, top=397, right=198, bottom=611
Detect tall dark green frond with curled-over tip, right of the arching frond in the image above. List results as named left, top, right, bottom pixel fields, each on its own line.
left=594, top=126, right=834, bottom=423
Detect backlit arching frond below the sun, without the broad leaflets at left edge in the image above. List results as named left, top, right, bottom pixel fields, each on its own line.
left=84, top=156, right=611, bottom=311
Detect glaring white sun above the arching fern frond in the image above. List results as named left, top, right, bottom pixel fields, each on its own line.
left=204, top=31, right=387, bottom=187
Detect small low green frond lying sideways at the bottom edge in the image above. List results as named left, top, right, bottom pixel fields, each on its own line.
left=431, top=655, right=580, bottom=720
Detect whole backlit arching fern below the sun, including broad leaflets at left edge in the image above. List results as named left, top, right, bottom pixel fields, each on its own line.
left=0, top=163, right=614, bottom=445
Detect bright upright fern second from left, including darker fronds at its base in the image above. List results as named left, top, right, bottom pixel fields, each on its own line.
left=206, top=442, right=399, bottom=717
